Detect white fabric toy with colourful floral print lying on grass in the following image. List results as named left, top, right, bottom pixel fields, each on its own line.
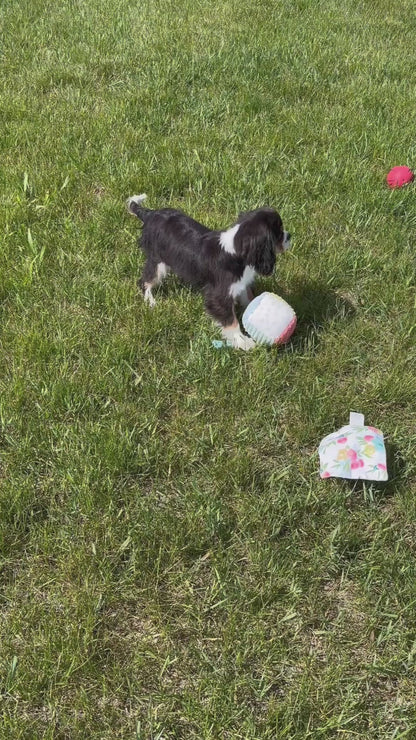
left=319, top=412, right=388, bottom=481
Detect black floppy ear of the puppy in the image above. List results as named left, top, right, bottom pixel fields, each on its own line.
left=234, top=218, right=276, bottom=275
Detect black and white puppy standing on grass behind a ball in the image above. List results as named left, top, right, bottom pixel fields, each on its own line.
left=127, top=194, right=290, bottom=350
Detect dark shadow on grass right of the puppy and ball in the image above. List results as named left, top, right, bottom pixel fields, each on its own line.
left=275, top=281, right=356, bottom=352
